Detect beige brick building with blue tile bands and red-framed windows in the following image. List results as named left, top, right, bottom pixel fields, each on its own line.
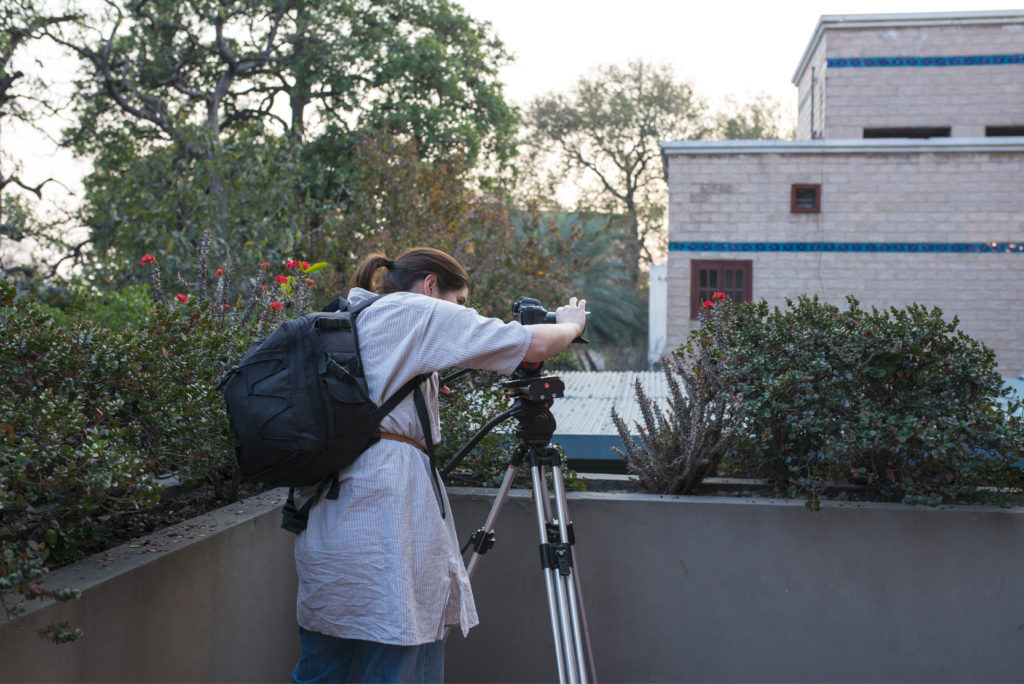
left=662, top=10, right=1024, bottom=377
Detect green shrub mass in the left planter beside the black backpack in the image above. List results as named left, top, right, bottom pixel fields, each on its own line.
left=0, top=245, right=316, bottom=641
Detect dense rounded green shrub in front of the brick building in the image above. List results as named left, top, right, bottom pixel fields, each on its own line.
left=693, top=297, right=1024, bottom=507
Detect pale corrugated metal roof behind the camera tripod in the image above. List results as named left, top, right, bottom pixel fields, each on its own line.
left=551, top=371, right=669, bottom=435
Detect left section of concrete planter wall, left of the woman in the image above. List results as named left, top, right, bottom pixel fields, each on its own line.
left=0, top=490, right=300, bottom=682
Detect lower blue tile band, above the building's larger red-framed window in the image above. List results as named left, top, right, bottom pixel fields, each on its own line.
left=669, top=242, right=1024, bottom=254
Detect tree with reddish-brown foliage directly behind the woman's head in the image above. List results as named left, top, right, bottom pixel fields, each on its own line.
left=332, top=134, right=580, bottom=318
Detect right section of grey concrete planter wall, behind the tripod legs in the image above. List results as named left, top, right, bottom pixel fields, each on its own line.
left=446, top=493, right=1024, bottom=682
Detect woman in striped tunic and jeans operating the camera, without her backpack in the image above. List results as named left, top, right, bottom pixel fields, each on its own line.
left=292, top=248, right=586, bottom=682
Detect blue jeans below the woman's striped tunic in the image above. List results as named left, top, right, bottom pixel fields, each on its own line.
left=292, top=627, right=444, bottom=684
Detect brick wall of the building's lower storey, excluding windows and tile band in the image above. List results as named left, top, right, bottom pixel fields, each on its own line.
left=668, top=146, right=1024, bottom=377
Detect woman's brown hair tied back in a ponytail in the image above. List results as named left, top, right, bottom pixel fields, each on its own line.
left=349, top=247, right=469, bottom=295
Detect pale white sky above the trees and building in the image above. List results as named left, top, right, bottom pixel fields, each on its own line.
left=8, top=0, right=1024, bottom=227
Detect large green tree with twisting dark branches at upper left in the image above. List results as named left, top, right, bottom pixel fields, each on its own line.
left=48, top=0, right=515, bottom=282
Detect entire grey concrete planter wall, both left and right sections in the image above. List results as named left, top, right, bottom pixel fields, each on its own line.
left=8, top=489, right=1024, bottom=682
